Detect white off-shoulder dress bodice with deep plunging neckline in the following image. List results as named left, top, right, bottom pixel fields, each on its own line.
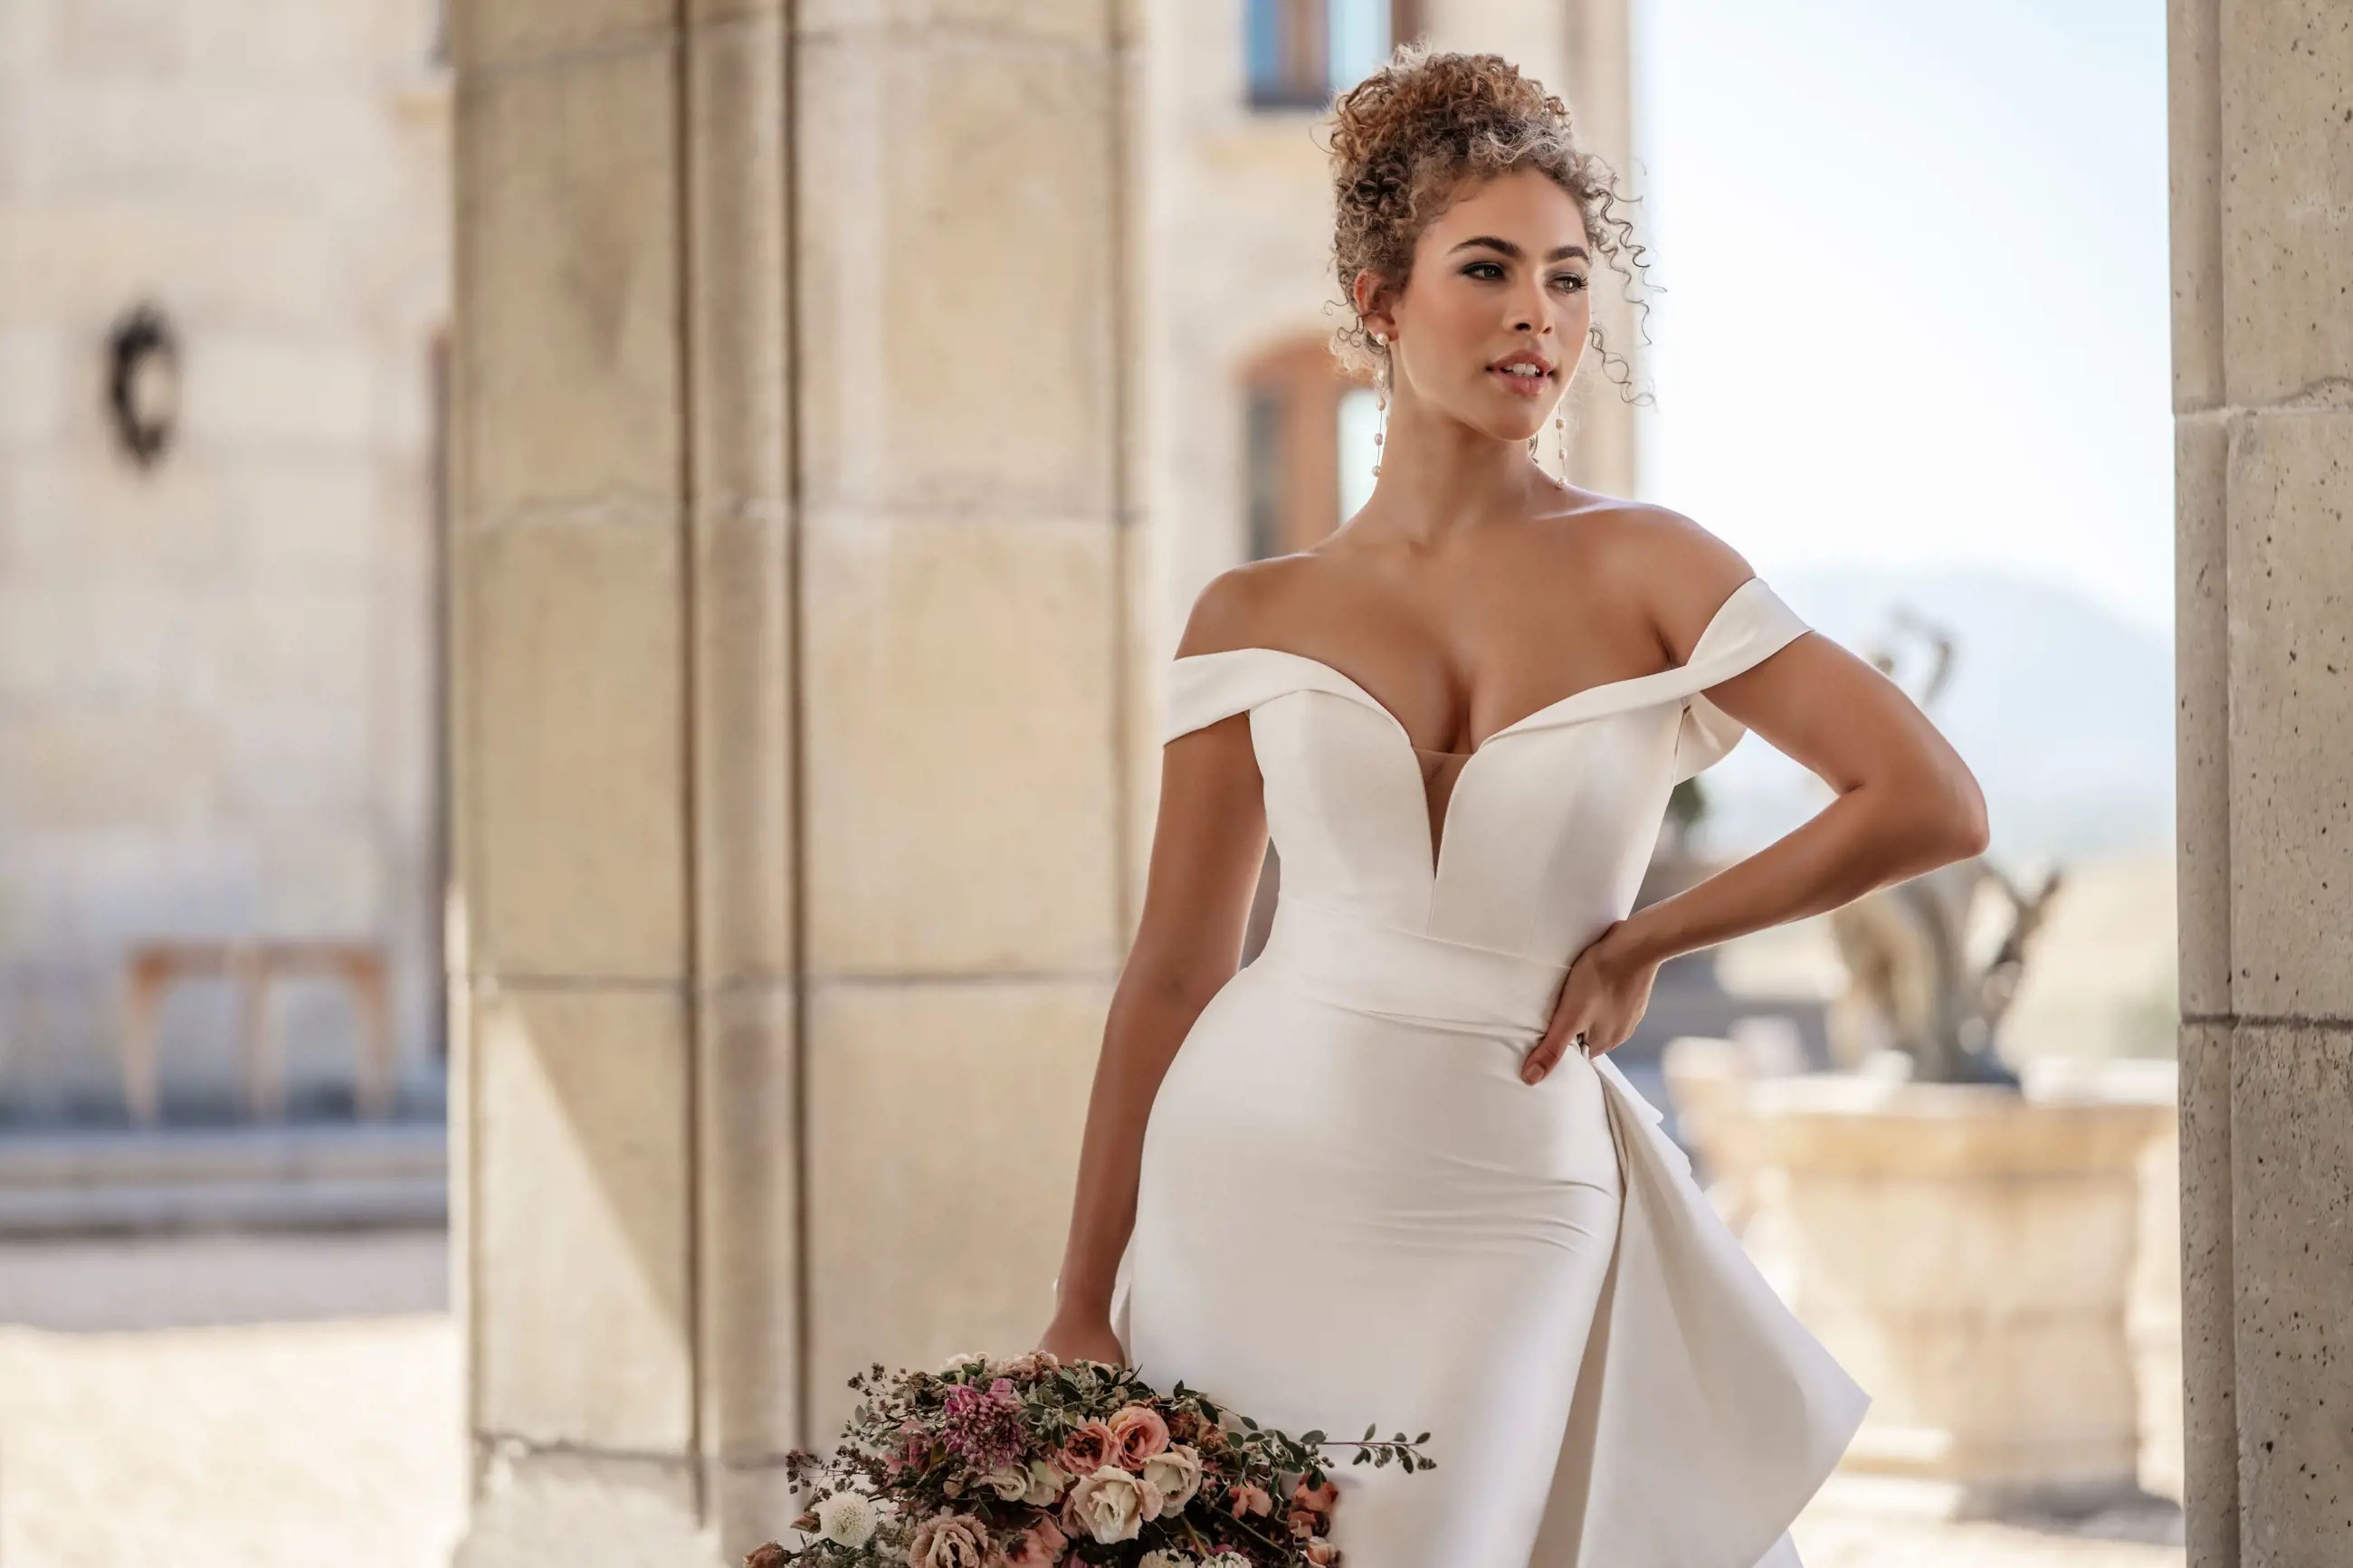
left=1162, top=576, right=1807, bottom=964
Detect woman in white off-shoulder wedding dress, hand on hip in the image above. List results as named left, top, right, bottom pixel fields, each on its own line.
left=1038, top=47, right=1986, bottom=1568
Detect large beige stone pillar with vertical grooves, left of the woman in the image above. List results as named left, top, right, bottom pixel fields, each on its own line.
left=452, top=0, right=1148, bottom=1568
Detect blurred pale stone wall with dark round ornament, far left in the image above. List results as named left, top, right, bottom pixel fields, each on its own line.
left=0, top=0, right=450, bottom=1119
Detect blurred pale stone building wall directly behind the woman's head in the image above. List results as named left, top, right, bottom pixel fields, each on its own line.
left=1141, top=0, right=1650, bottom=644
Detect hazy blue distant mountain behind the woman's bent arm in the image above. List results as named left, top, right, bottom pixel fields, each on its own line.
left=1701, top=566, right=2174, bottom=865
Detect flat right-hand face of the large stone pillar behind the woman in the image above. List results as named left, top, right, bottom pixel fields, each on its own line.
left=795, top=0, right=1157, bottom=1431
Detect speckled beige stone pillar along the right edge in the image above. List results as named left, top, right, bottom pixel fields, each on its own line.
left=2167, top=0, right=2353, bottom=1568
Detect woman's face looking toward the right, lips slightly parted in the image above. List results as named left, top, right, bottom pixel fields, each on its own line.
left=1365, top=169, right=1593, bottom=442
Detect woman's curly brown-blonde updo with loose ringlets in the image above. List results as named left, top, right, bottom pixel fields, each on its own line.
left=1329, top=43, right=1650, bottom=402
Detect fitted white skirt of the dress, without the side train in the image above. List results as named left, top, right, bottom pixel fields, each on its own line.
left=1120, top=955, right=1621, bottom=1568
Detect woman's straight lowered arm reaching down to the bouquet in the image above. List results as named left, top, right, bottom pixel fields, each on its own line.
left=1038, top=574, right=1266, bottom=1361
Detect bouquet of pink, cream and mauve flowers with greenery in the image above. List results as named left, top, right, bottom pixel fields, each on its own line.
left=744, top=1352, right=1438, bottom=1568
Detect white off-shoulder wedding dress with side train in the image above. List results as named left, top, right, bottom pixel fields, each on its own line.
left=1113, top=578, right=1868, bottom=1568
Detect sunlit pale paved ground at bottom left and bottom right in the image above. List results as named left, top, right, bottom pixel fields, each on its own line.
left=0, top=1234, right=2181, bottom=1568
